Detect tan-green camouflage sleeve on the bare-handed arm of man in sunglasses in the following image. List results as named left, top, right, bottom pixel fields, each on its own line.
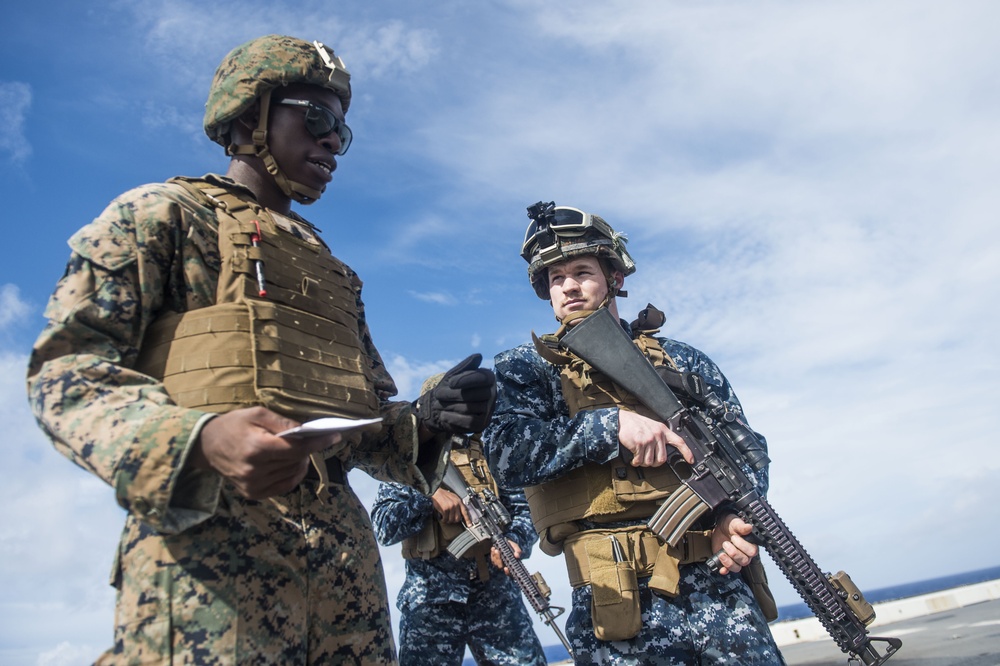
left=28, top=185, right=219, bottom=532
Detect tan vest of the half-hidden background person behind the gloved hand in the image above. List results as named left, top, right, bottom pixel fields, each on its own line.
left=403, top=435, right=500, bottom=581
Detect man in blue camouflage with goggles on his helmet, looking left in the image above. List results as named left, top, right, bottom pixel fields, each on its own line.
left=483, top=202, right=784, bottom=666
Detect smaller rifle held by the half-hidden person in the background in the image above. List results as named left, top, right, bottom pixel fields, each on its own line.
left=443, top=461, right=573, bottom=658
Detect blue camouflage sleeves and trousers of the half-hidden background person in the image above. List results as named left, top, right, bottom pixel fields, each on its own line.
left=372, top=436, right=546, bottom=666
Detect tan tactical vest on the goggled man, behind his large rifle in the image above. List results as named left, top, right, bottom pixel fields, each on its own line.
left=525, top=313, right=680, bottom=555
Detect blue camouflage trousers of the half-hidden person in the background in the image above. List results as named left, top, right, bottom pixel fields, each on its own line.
left=399, top=571, right=546, bottom=666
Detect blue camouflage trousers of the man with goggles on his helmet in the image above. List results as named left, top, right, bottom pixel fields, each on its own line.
left=566, top=564, right=785, bottom=666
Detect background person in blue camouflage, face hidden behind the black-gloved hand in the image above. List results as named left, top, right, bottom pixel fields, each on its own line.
left=371, top=376, right=546, bottom=666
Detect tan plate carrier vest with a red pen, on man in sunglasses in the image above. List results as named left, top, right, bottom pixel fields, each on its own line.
left=136, top=178, right=379, bottom=485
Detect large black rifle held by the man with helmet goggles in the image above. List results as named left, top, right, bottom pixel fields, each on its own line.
left=560, top=308, right=902, bottom=666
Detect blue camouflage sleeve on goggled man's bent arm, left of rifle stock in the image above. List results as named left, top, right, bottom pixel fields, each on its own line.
left=483, top=344, right=618, bottom=489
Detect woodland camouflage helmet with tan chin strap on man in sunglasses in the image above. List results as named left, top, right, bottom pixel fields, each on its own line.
left=203, top=35, right=351, bottom=203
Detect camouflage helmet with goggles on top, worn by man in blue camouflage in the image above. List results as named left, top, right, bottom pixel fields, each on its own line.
left=521, top=201, right=635, bottom=301
